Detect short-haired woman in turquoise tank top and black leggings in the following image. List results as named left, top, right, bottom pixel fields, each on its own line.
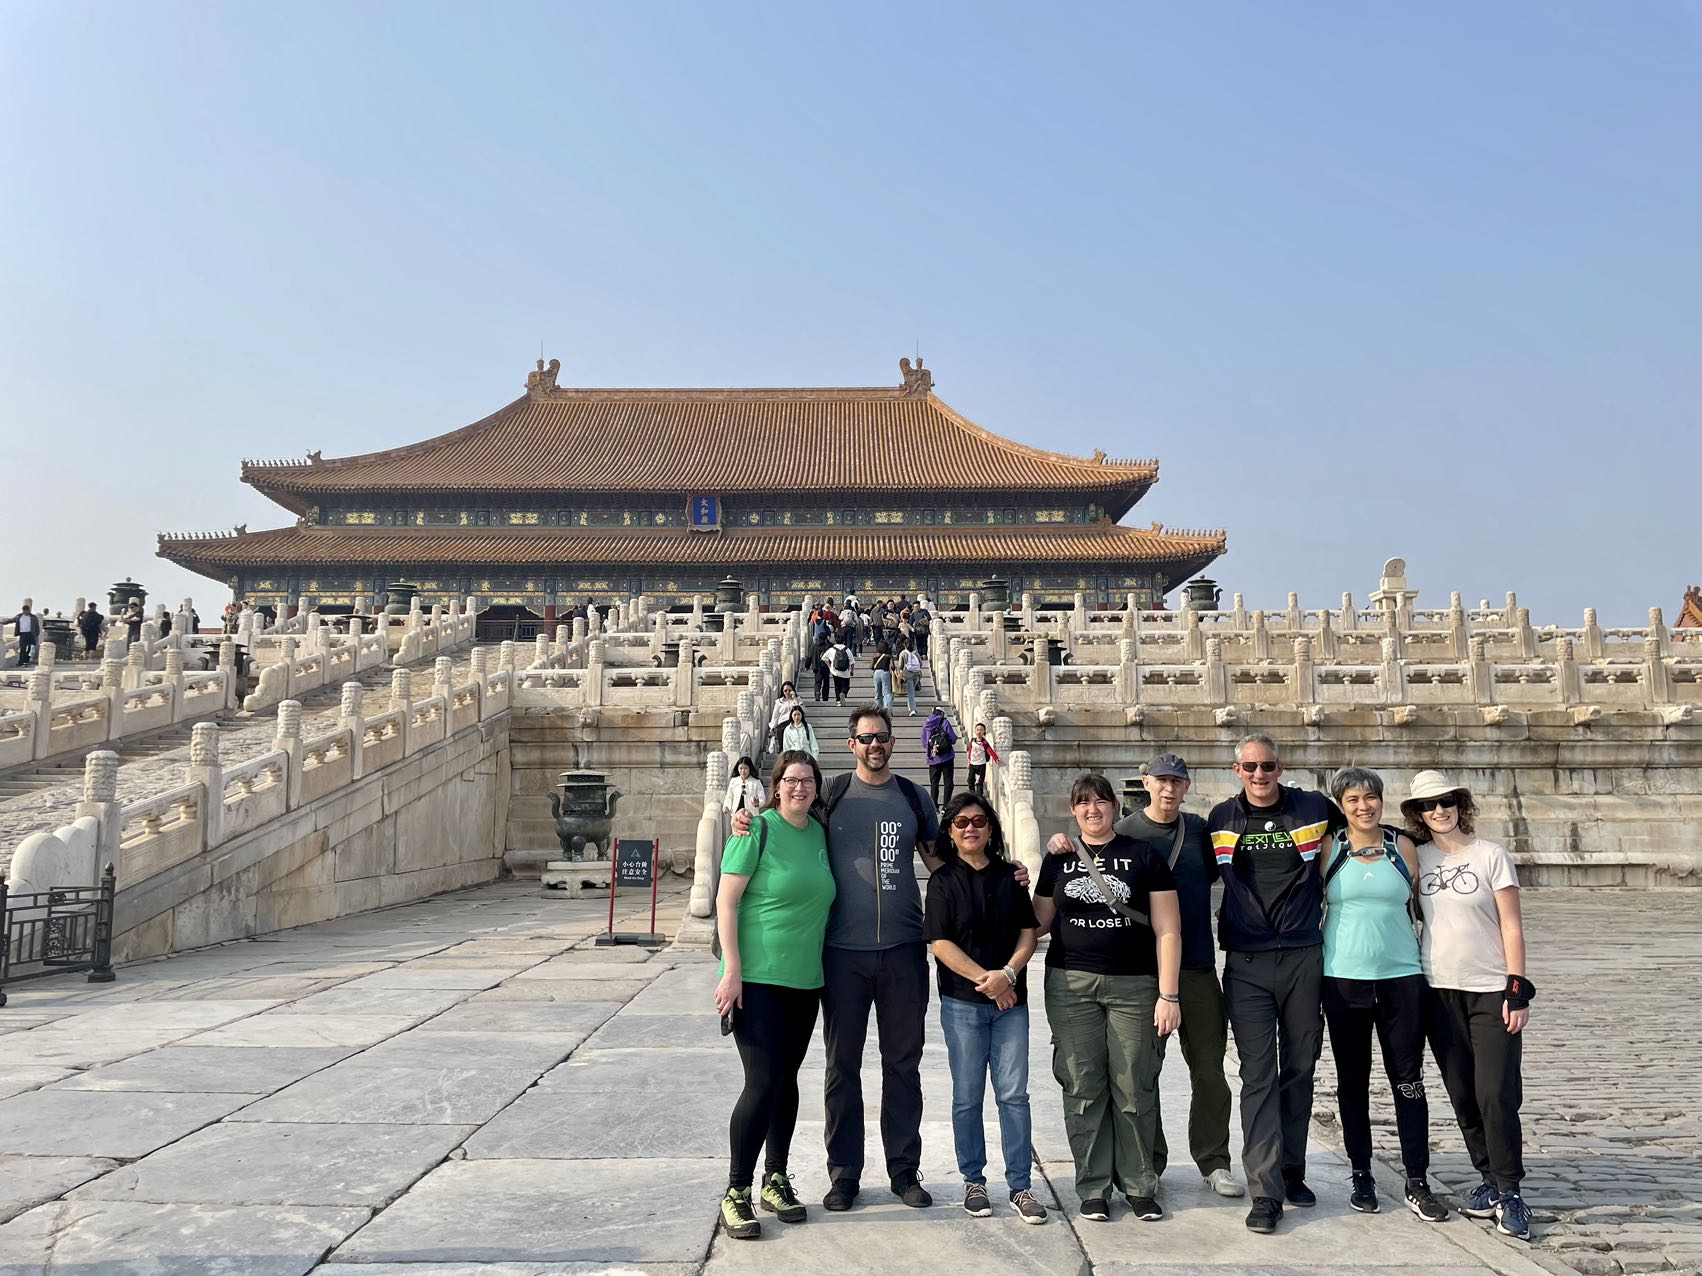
left=1324, top=767, right=1448, bottom=1223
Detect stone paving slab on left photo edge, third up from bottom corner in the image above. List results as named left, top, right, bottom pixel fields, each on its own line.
left=0, top=1091, right=250, bottom=1160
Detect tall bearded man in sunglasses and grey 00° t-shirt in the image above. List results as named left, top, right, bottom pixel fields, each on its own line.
left=732, top=708, right=1028, bottom=1211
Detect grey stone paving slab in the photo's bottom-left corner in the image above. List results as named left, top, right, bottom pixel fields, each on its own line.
left=0, top=1201, right=368, bottom=1276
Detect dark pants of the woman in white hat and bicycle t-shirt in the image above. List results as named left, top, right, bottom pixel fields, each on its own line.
left=1425, top=988, right=1525, bottom=1193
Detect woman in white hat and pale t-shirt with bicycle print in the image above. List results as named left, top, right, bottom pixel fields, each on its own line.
left=1401, top=771, right=1535, bottom=1240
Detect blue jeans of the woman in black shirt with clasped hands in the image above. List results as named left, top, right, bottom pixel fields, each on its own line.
left=940, top=997, right=1035, bottom=1193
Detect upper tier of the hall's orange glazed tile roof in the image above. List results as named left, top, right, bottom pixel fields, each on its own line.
left=242, top=388, right=1157, bottom=517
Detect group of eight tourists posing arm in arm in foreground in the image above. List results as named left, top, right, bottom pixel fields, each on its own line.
left=715, top=721, right=1535, bottom=1239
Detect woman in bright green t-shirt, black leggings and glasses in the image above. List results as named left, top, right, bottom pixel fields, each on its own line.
left=715, top=749, right=834, bottom=1240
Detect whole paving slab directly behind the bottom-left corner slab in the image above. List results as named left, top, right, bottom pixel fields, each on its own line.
left=71, top=1121, right=471, bottom=1208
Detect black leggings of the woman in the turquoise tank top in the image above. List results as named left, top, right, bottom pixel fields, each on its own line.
left=1324, top=975, right=1430, bottom=1179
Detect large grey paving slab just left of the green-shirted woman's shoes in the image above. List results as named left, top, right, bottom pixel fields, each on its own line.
left=334, top=1157, right=727, bottom=1264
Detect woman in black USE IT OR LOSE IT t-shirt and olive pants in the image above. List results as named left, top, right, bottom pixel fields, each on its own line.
left=1035, top=772, right=1181, bottom=1222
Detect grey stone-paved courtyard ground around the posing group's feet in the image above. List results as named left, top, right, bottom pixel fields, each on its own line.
left=0, top=883, right=1702, bottom=1276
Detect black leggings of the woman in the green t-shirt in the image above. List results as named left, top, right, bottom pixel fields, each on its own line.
left=727, top=983, right=822, bottom=1188
